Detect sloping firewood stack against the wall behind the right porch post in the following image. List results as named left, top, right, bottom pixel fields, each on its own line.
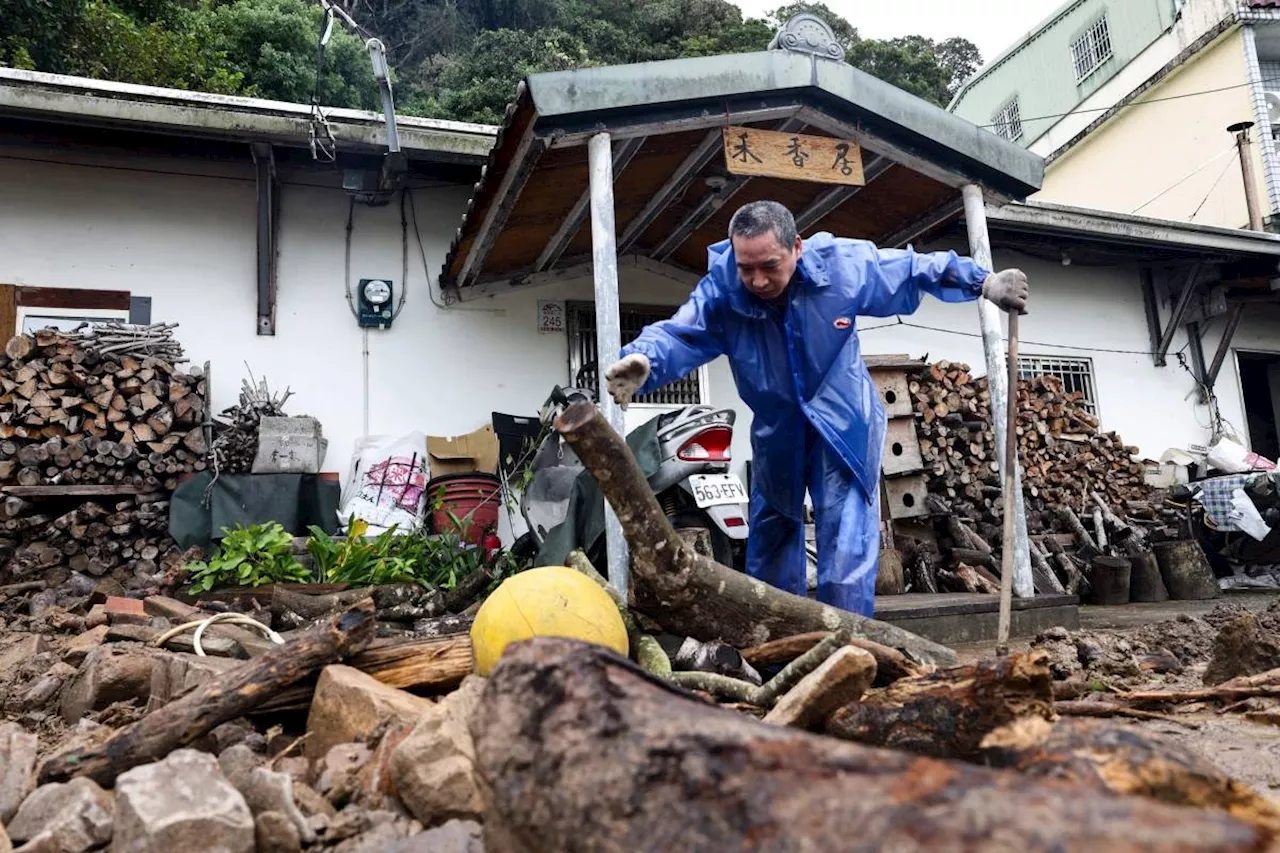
left=910, top=361, right=1149, bottom=525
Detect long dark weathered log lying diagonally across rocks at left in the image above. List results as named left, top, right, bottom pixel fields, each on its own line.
left=40, top=602, right=374, bottom=786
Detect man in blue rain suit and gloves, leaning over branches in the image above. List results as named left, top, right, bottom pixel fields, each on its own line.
left=605, top=201, right=1028, bottom=616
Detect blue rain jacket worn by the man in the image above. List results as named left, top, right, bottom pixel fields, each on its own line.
left=622, top=233, right=989, bottom=507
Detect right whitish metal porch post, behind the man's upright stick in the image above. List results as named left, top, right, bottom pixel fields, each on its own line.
left=961, top=183, right=1036, bottom=598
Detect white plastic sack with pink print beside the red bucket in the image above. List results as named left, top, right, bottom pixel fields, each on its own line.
left=338, top=433, right=429, bottom=530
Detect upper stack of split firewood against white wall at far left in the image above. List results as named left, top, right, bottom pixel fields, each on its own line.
left=0, top=329, right=206, bottom=489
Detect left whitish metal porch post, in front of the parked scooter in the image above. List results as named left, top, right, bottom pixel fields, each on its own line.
left=588, top=133, right=631, bottom=601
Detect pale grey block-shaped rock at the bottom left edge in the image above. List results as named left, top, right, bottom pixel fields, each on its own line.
left=114, top=749, right=255, bottom=853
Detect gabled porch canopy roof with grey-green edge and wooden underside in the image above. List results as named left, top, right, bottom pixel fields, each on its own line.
left=442, top=40, right=1044, bottom=298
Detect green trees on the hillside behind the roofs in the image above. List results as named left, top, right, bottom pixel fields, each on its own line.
left=0, top=0, right=980, bottom=122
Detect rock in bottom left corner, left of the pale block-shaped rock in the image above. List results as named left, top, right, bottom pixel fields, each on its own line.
left=8, top=777, right=111, bottom=853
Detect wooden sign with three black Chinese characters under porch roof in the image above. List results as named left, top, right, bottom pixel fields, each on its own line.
left=724, top=127, right=867, bottom=187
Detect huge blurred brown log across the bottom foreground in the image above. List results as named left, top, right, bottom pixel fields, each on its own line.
left=471, top=638, right=1268, bottom=853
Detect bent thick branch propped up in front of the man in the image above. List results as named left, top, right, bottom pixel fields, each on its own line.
left=556, top=402, right=955, bottom=665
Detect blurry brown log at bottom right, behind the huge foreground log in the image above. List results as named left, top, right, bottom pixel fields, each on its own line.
left=983, top=717, right=1280, bottom=839
